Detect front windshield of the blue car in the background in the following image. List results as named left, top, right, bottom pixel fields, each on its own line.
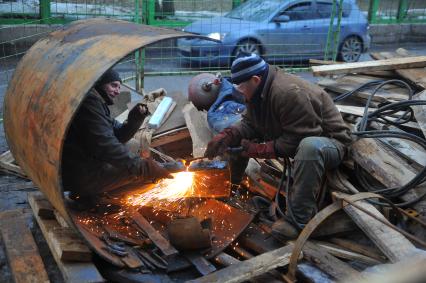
left=225, top=0, right=283, bottom=22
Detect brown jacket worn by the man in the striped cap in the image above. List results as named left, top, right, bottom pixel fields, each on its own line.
left=235, top=66, right=351, bottom=157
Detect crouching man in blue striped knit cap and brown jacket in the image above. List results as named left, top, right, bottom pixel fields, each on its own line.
left=205, top=54, right=351, bottom=238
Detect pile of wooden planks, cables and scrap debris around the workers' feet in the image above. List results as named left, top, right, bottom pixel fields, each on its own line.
left=0, top=49, right=426, bottom=282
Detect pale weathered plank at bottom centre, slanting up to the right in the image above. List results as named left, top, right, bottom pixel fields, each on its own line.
left=187, top=244, right=293, bottom=283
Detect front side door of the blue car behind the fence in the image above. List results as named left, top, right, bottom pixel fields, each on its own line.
left=267, top=1, right=314, bottom=60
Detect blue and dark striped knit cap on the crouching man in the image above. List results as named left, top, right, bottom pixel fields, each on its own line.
left=231, top=53, right=267, bottom=84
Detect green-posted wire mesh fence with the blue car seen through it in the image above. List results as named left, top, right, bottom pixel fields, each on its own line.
left=0, top=0, right=426, bottom=90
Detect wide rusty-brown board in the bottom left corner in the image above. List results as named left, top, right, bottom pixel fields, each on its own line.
left=0, top=210, right=49, bottom=283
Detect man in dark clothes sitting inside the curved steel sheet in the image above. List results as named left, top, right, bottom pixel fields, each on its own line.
left=62, top=69, right=171, bottom=205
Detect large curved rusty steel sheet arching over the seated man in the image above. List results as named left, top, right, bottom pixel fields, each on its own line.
left=4, top=18, right=209, bottom=226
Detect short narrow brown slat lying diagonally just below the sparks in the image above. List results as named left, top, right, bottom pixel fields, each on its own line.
left=131, top=211, right=179, bottom=257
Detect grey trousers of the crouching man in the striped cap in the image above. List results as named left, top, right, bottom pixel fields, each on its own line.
left=229, top=137, right=345, bottom=224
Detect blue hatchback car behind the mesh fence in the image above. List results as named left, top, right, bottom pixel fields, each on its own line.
left=177, top=0, right=371, bottom=66
